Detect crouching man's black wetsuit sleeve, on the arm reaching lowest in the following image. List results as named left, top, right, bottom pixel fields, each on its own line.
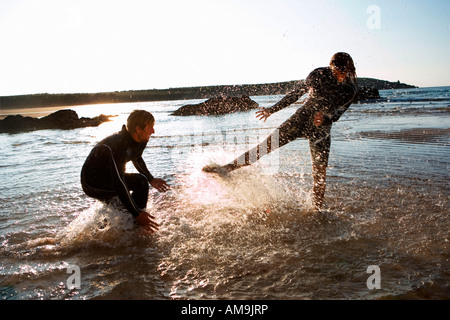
left=101, top=144, right=142, bottom=217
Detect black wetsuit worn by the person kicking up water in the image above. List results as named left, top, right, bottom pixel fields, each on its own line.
left=230, top=67, right=357, bottom=168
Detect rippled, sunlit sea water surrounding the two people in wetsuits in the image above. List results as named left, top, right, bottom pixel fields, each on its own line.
left=0, top=87, right=450, bottom=300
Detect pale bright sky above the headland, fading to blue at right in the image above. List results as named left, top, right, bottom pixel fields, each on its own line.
left=0, top=0, right=450, bottom=96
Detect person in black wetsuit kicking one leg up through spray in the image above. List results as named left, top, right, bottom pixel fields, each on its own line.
left=203, top=52, right=357, bottom=210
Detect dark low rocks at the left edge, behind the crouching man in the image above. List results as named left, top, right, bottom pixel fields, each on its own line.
left=0, top=110, right=111, bottom=133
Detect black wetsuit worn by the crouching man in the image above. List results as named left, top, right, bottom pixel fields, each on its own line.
left=81, top=126, right=153, bottom=217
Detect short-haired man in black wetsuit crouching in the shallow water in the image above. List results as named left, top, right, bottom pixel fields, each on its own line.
left=81, top=110, right=169, bottom=231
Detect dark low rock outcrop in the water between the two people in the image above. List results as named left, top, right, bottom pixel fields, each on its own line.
left=171, top=96, right=258, bottom=116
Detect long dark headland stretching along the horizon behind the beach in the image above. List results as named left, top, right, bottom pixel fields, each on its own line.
left=0, top=78, right=417, bottom=109
